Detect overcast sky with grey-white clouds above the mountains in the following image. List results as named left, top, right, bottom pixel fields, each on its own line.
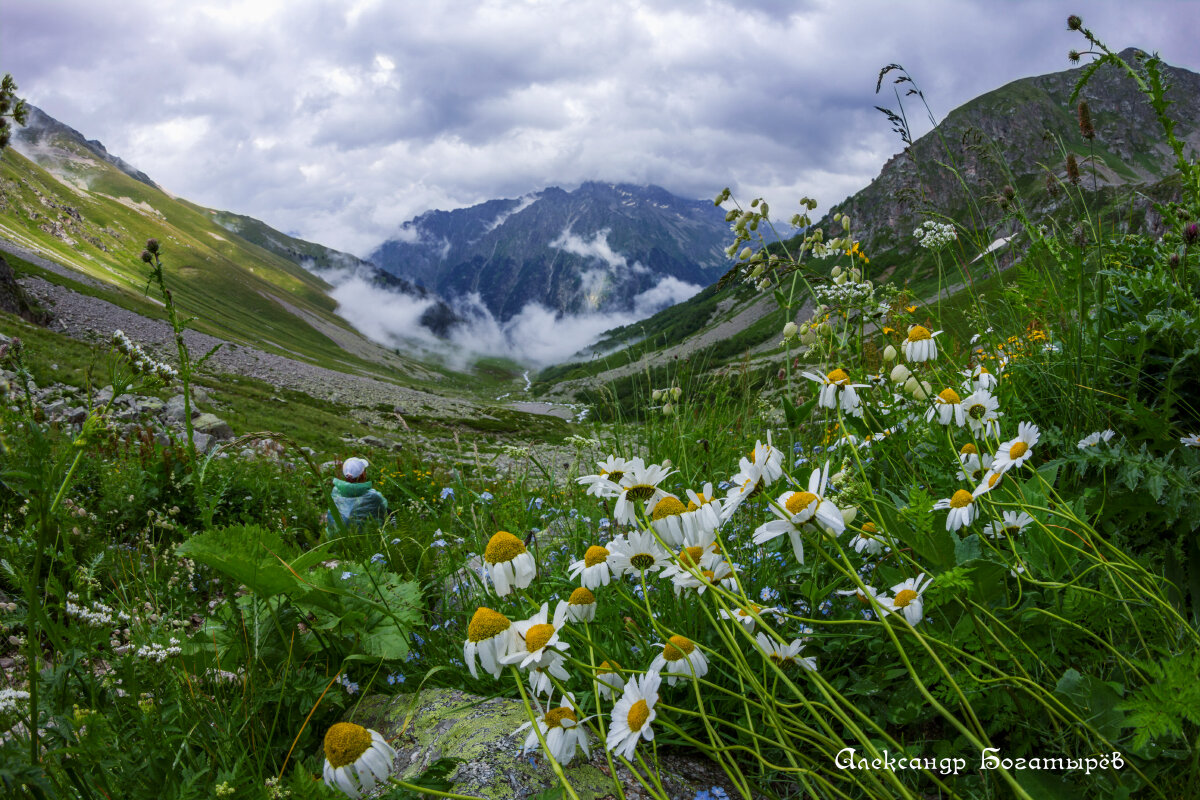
left=0, top=0, right=1200, bottom=255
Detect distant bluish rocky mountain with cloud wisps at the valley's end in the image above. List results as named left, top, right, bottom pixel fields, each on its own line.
left=368, top=182, right=731, bottom=321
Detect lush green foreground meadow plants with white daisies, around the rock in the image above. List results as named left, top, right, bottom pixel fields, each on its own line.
left=0, top=18, right=1200, bottom=799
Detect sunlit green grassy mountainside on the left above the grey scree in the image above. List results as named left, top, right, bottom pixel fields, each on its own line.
left=0, top=107, right=445, bottom=384
